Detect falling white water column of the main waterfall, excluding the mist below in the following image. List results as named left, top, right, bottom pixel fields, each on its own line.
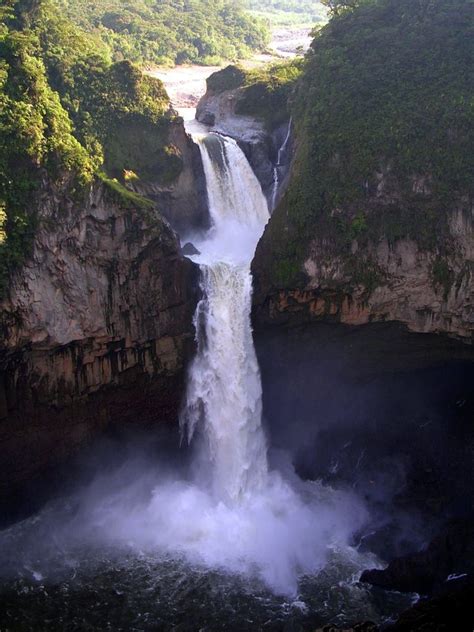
left=181, top=134, right=269, bottom=502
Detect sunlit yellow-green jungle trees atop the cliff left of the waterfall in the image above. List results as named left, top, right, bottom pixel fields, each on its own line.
left=0, top=0, right=181, bottom=293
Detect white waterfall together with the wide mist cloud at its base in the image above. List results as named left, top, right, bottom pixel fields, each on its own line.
left=0, top=126, right=367, bottom=600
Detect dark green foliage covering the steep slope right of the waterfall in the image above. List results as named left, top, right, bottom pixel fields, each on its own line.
left=266, top=0, right=474, bottom=286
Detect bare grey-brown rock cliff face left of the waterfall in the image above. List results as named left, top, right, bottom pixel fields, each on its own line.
left=0, top=177, right=197, bottom=504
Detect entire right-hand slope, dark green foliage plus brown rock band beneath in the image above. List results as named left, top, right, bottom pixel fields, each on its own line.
left=253, top=0, right=474, bottom=342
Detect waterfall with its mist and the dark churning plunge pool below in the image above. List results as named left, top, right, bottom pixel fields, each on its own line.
left=0, top=126, right=407, bottom=630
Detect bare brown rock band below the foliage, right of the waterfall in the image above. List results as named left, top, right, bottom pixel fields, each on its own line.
left=253, top=189, right=474, bottom=343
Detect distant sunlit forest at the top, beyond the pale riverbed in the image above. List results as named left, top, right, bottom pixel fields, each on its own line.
left=58, top=0, right=268, bottom=65
